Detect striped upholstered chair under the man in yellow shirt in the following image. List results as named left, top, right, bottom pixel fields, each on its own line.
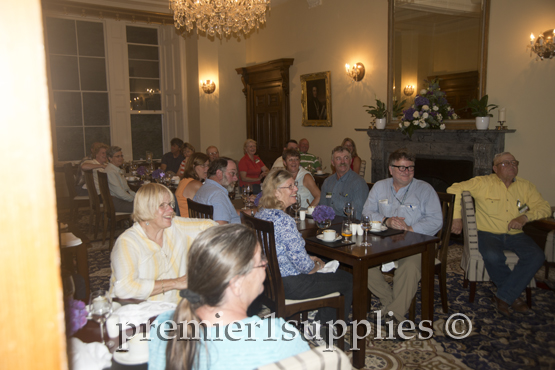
left=461, top=191, right=536, bottom=307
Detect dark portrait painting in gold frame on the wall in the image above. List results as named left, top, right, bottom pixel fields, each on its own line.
left=301, top=71, right=331, bottom=127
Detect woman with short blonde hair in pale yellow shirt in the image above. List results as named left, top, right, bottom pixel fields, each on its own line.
left=110, top=183, right=217, bottom=303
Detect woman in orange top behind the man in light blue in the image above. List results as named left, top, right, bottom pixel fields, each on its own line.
left=175, top=153, right=210, bottom=217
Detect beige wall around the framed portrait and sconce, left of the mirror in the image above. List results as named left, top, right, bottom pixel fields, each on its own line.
left=246, top=0, right=387, bottom=181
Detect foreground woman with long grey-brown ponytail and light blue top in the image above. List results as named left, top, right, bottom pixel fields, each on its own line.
left=148, top=224, right=309, bottom=370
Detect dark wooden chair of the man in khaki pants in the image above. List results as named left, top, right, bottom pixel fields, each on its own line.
left=409, top=192, right=455, bottom=322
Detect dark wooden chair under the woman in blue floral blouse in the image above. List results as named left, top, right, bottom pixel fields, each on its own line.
left=241, top=213, right=344, bottom=349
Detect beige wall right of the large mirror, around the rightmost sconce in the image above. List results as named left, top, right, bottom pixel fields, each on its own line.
left=487, top=0, right=555, bottom=205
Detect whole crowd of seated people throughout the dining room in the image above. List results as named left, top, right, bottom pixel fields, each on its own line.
left=77, top=138, right=550, bottom=369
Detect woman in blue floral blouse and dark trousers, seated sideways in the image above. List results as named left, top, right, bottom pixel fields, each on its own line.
left=255, top=169, right=353, bottom=333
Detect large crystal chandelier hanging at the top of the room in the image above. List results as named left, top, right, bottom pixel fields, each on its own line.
left=170, top=0, right=270, bottom=38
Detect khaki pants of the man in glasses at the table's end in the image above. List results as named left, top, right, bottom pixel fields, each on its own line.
left=368, top=254, right=422, bottom=322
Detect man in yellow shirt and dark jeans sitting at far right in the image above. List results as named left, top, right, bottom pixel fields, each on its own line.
left=447, top=152, right=551, bottom=316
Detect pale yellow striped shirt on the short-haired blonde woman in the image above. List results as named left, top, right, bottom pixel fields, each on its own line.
left=110, top=217, right=217, bottom=303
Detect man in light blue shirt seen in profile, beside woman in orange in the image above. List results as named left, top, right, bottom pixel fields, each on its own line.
left=193, top=157, right=241, bottom=225
